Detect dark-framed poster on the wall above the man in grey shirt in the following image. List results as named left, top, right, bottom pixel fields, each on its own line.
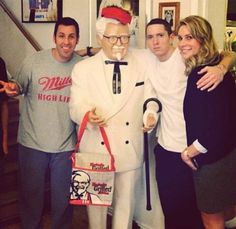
left=21, top=0, right=62, bottom=23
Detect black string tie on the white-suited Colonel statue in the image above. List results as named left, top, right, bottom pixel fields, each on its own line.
left=105, top=60, right=128, bottom=94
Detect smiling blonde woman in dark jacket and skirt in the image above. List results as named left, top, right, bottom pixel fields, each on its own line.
left=178, top=16, right=236, bottom=229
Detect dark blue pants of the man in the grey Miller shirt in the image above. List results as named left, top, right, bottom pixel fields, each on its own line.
left=19, top=145, right=72, bottom=229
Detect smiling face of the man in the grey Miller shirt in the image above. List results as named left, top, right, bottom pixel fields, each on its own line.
left=53, top=25, right=78, bottom=62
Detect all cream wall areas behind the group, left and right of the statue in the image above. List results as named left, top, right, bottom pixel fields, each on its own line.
left=0, top=0, right=227, bottom=74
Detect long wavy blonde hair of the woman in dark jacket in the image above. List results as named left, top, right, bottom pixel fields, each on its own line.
left=177, top=15, right=220, bottom=75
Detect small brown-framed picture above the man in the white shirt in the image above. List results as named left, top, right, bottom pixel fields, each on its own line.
left=159, top=2, right=180, bottom=32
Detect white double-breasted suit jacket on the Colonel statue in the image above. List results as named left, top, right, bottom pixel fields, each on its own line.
left=69, top=50, right=146, bottom=172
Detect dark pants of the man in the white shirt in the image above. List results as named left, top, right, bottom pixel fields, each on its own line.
left=154, top=145, right=204, bottom=229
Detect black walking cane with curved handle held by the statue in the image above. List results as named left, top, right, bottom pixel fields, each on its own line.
left=143, top=98, right=162, bottom=211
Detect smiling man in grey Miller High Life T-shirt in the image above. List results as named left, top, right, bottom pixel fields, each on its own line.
left=0, top=17, right=79, bottom=229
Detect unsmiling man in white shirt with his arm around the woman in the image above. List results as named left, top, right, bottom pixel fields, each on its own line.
left=144, top=19, right=236, bottom=229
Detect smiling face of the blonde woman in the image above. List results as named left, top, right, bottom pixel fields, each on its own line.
left=178, top=25, right=201, bottom=60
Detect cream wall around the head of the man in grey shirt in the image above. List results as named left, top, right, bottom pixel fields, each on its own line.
left=0, top=0, right=90, bottom=75
